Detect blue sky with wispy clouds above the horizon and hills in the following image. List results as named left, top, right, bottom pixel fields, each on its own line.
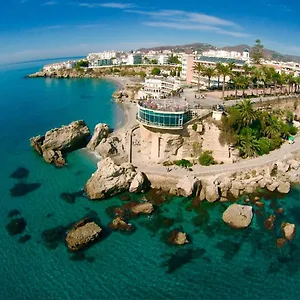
left=0, top=0, right=300, bottom=63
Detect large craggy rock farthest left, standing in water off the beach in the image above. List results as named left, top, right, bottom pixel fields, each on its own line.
left=30, top=120, right=90, bottom=166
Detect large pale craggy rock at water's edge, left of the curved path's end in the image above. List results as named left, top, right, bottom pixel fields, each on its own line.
left=84, top=157, right=137, bottom=200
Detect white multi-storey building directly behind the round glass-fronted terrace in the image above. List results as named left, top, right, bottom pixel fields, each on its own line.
left=138, top=76, right=181, bottom=99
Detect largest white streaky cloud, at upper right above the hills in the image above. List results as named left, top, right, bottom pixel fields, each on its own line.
left=125, top=9, right=249, bottom=37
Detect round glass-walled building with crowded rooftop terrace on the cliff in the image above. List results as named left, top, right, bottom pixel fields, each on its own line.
left=137, top=98, right=192, bottom=130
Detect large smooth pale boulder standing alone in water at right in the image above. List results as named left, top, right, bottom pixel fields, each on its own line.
left=223, top=203, right=253, bottom=229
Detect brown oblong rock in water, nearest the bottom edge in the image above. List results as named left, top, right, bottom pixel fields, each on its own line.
left=66, top=219, right=102, bottom=251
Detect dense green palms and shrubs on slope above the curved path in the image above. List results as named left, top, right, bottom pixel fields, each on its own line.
left=220, top=100, right=297, bottom=158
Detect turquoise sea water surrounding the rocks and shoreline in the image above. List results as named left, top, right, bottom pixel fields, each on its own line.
left=0, top=62, right=300, bottom=299
